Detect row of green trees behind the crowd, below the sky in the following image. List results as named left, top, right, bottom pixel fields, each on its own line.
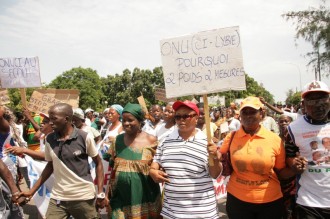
left=5, top=67, right=274, bottom=111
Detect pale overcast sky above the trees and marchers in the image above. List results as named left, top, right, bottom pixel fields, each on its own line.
left=0, top=0, right=330, bottom=101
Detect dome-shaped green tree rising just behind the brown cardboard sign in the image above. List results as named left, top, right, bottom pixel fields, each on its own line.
left=47, top=67, right=104, bottom=110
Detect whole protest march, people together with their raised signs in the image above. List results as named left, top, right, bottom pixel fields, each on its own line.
left=0, top=26, right=330, bottom=219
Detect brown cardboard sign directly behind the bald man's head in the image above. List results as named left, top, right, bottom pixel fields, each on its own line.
left=27, top=89, right=79, bottom=113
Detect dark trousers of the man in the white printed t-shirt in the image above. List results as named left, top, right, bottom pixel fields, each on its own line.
left=296, top=204, right=330, bottom=219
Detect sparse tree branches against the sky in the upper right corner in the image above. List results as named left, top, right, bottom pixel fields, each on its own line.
left=282, top=0, right=330, bottom=76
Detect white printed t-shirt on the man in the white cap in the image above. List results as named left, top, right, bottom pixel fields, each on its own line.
left=286, top=116, right=330, bottom=208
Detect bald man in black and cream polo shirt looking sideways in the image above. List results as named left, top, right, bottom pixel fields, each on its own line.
left=24, top=103, right=108, bottom=219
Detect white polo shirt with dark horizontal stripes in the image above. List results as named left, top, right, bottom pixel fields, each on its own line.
left=154, top=129, right=219, bottom=219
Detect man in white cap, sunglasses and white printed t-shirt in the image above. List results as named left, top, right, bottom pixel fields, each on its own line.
left=285, top=81, right=330, bottom=218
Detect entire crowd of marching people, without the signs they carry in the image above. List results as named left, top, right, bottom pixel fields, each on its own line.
left=0, top=81, right=330, bottom=219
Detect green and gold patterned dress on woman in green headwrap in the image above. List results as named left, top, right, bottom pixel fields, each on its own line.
left=109, top=134, right=161, bottom=219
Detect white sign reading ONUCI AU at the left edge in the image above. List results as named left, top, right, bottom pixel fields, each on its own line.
left=0, top=57, right=41, bottom=88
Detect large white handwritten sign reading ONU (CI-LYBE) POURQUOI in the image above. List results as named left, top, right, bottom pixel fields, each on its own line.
left=160, top=27, right=246, bottom=98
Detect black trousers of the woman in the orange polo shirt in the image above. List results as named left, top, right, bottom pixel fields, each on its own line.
left=226, top=193, right=284, bottom=219
